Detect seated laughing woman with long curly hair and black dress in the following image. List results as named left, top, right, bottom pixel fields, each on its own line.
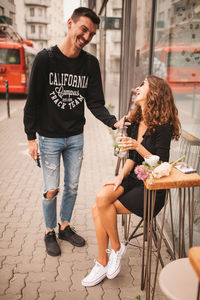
left=82, top=76, right=180, bottom=286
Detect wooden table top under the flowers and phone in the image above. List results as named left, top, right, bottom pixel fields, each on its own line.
left=144, top=167, right=200, bottom=190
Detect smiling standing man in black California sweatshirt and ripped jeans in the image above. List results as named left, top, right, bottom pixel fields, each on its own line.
left=24, top=7, right=126, bottom=256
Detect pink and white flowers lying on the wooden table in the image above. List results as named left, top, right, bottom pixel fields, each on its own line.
left=134, top=155, right=185, bottom=184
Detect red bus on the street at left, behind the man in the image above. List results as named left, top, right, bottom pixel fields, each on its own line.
left=0, top=27, right=37, bottom=95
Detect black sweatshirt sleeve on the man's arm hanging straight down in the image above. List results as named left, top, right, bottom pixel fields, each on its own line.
left=24, top=50, right=48, bottom=140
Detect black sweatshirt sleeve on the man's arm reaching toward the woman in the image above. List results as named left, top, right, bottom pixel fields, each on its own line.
left=86, top=56, right=117, bottom=129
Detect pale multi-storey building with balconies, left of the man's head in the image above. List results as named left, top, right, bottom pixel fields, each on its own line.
left=0, top=0, right=65, bottom=49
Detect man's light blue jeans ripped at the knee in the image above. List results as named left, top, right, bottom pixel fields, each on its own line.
left=39, top=133, right=83, bottom=229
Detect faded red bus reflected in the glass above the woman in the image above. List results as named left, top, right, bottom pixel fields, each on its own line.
left=153, top=44, right=200, bottom=94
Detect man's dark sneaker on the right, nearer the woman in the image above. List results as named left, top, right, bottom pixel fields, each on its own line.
left=58, top=224, right=85, bottom=247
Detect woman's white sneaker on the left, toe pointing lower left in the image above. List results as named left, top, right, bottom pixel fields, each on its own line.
left=81, top=261, right=108, bottom=286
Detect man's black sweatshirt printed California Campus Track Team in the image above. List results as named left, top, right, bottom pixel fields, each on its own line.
left=24, top=46, right=117, bottom=140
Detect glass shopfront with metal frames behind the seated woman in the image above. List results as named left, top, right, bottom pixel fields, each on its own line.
left=88, top=0, right=200, bottom=248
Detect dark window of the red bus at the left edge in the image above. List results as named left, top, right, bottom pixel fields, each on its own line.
left=0, top=48, right=20, bottom=65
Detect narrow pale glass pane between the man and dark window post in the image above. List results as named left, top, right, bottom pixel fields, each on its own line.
left=99, top=0, right=122, bottom=116
